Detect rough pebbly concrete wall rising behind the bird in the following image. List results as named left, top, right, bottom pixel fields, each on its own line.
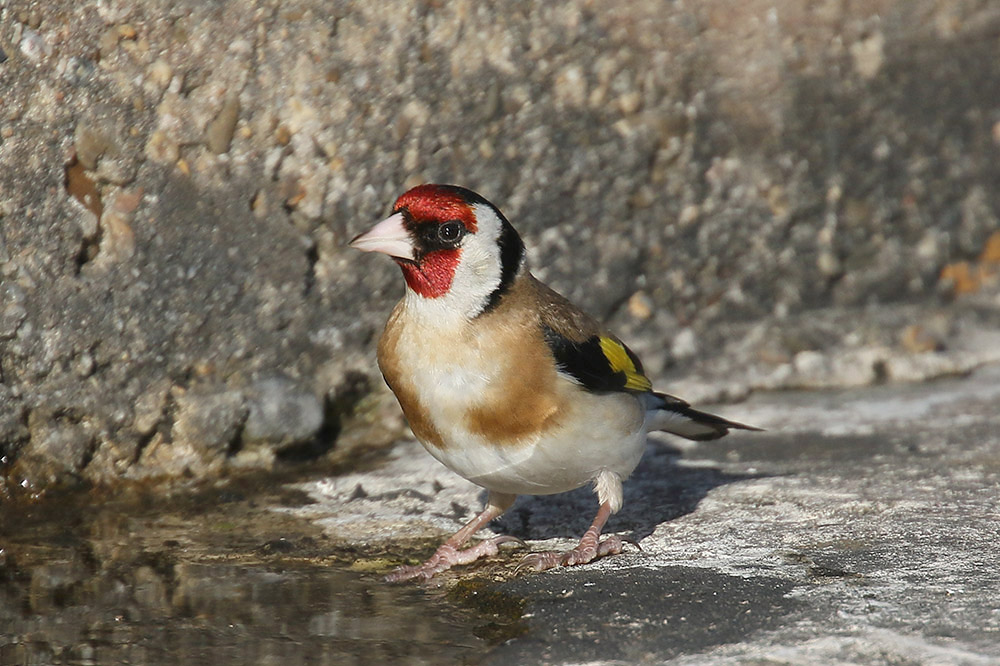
left=0, top=0, right=1000, bottom=489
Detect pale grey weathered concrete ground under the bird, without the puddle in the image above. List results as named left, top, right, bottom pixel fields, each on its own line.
left=302, top=366, right=1000, bottom=665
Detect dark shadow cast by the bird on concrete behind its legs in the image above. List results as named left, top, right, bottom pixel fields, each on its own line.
left=483, top=442, right=761, bottom=541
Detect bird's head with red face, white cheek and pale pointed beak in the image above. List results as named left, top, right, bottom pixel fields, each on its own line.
left=350, top=185, right=524, bottom=318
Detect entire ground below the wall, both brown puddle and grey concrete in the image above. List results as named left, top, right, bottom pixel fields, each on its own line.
left=0, top=366, right=1000, bottom=666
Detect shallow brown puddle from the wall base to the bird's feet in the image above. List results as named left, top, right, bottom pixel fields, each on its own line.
left=0, top=480, right=504, bottom=666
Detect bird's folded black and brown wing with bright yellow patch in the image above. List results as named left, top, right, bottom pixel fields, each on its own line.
left=535, top=281, right=652, bottom=393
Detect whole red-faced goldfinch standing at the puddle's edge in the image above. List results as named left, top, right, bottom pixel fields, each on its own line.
left=349, top=184, right=760, bottom=582
